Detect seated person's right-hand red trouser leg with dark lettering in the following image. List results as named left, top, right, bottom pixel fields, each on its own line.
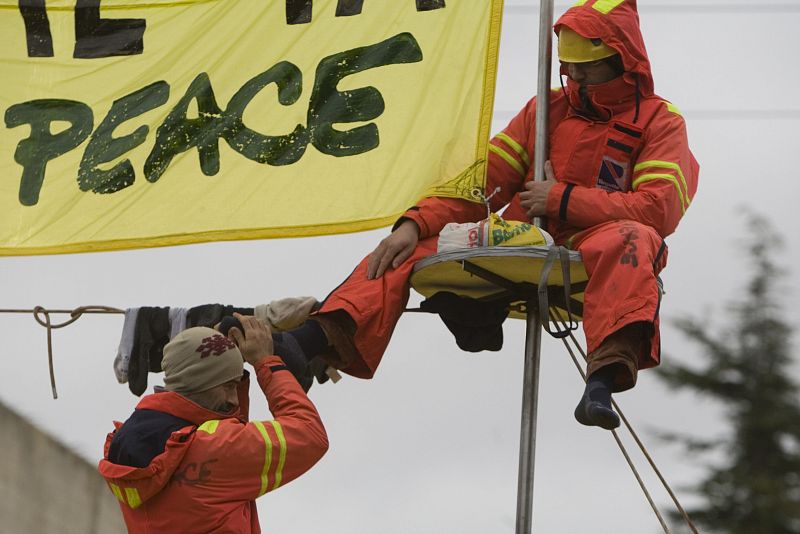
left=574, top=220, right=667, bottom=385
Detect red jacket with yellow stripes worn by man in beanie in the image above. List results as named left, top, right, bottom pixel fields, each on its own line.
left=98, top=356, right=328, bottom=534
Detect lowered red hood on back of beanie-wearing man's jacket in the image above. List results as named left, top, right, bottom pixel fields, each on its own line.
left=98, top=391, right=238, bottom=508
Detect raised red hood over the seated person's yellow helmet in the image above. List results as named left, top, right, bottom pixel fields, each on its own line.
left=553, top=0, right=655, bottom=97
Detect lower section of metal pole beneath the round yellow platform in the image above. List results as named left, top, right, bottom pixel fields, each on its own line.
left=516, top=301, right=542, bottom=534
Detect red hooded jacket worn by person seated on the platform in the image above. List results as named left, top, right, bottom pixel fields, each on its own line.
left=404, top=0, right=699, bottom=244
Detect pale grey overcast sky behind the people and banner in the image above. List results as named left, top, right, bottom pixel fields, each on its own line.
left=0, top=0, right=800, bottom=534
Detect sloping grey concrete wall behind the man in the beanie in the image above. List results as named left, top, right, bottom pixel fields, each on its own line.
left=0, top=403, right=126, bottom=534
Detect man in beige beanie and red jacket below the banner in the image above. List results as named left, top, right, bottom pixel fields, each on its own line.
left=98, top=315, right=328, bottom=534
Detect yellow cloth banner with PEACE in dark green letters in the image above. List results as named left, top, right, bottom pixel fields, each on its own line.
left=0, top=0, right=502, bottom=255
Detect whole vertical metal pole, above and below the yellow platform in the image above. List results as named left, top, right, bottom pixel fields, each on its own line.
left=516, top=0, right=553, bottom=534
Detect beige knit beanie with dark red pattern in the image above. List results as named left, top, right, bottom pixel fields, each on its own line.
left=161, top=326, right=244, bottom=393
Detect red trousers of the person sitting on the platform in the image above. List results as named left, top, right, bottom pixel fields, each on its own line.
left=319, top=220, right=667, bottom=389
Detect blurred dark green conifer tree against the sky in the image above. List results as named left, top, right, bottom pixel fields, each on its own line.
left=658, top=215, right=800, bottom=534
